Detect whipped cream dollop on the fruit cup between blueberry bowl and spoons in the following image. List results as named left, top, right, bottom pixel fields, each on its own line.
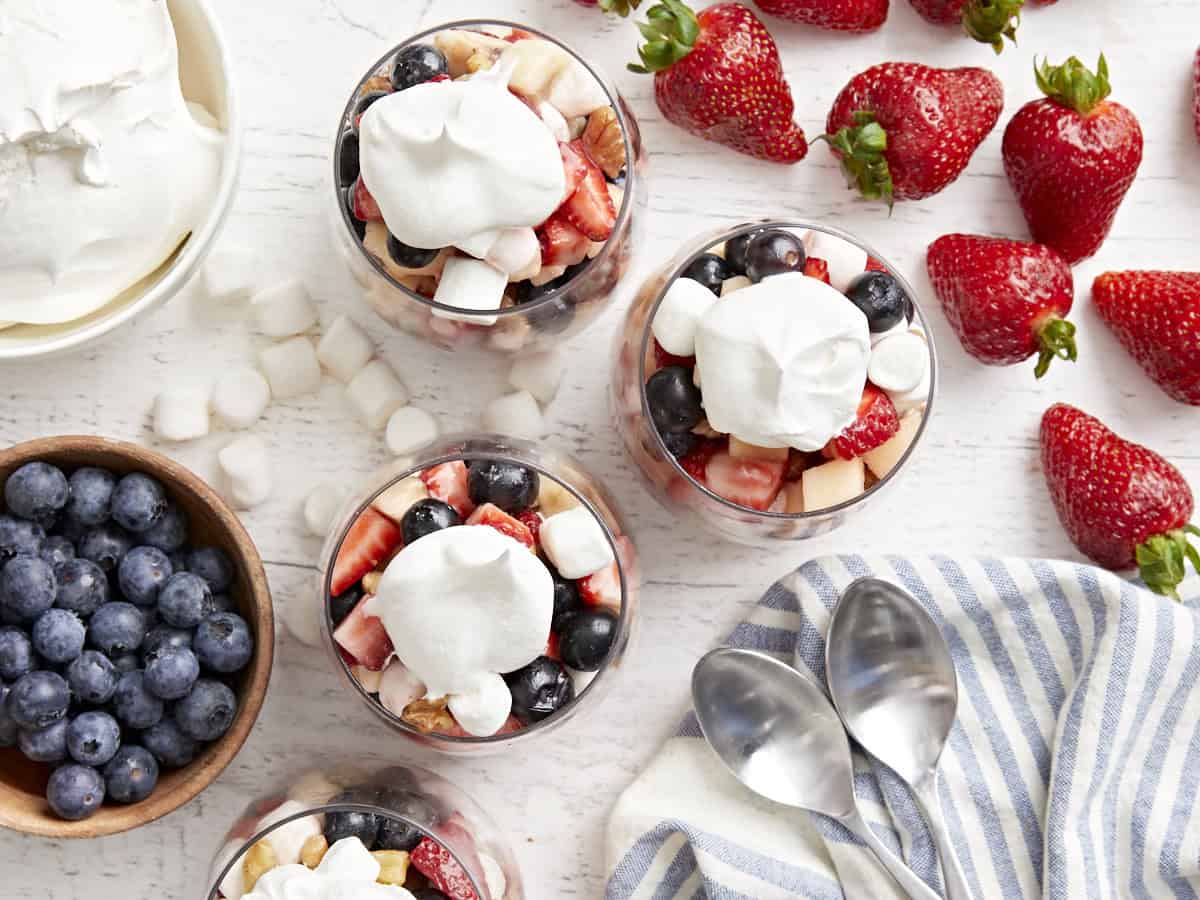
left=364, top=526, right=554, bottom=737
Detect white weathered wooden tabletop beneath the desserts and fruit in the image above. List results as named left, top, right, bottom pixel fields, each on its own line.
left=0, top=0, right=1200, bottom=900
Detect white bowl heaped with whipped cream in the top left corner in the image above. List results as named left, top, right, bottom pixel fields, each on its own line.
left=0, top=0, right=241, bottom=361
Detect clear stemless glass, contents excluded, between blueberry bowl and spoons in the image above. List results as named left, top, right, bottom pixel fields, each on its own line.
left=316, top=433, right=640, bottom=754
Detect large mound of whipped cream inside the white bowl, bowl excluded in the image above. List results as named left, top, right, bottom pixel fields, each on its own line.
left=0, top=0, right=223, bottom=324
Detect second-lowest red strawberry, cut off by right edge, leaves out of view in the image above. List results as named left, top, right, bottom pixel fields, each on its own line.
left=1092, top=271, right=1200, bottom=406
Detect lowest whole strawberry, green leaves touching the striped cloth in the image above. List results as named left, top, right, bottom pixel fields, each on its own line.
left=1042, top=403, right=1200, bottom=599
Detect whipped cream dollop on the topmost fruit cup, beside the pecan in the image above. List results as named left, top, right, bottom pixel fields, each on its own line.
left=359, top=58, right=566, bottom=256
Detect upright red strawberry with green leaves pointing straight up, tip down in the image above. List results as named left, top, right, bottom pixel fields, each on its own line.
left=1003, top=55, right=1142, bottom=265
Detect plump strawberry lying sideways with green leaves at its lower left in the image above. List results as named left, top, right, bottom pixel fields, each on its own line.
left=822, top=62, right=1004, bottom=204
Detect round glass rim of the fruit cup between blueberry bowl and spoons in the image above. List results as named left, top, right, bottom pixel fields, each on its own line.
left=322, top=432, right=632, bottom=746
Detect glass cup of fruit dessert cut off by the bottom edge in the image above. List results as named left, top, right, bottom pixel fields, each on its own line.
left=204, top=761, right=524, bottom=900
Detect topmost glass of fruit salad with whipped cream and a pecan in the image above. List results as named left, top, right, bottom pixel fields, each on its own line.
left=335, top=23, right=641, bottom=353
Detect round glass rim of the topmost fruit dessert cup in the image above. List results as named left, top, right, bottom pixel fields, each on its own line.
left=331, top=18, right=637, bottom=324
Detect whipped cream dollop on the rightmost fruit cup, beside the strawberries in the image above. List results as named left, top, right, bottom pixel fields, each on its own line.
left=696, top=272, right=871, bottom=451
